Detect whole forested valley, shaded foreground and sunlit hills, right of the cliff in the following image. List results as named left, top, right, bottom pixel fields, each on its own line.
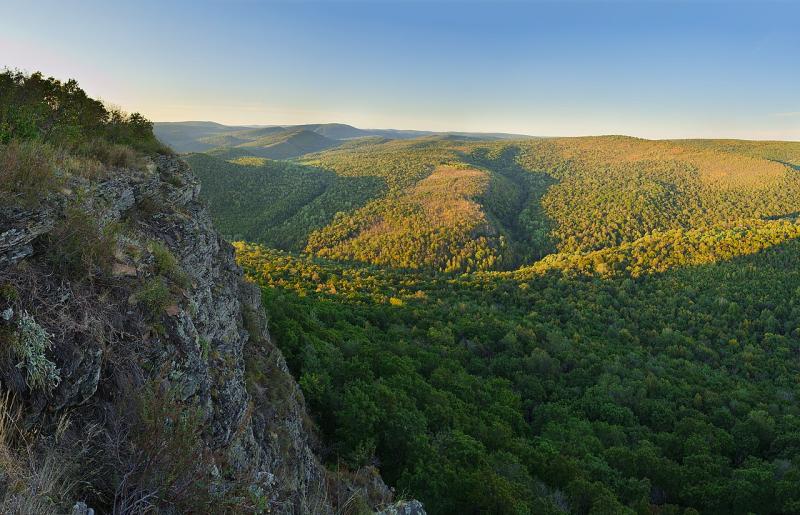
left=156, top=123, right=800, bottom=514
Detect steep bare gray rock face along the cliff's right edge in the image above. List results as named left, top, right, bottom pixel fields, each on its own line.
left=127, top=157, right=332, bottom=513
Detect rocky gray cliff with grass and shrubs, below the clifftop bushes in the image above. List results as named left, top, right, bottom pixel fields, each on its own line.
left=0, top=156, right=421, bottom=513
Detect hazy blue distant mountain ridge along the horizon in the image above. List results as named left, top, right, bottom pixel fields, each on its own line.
left=154, top=121, right=531, bottom=159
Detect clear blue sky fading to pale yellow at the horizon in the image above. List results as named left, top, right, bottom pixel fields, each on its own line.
left=0, top=0, right=800, bottom=140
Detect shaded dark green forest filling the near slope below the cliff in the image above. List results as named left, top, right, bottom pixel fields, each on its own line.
left=237, top=234, right=800, bottom=515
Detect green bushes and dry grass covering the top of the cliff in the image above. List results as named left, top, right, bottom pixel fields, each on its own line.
left=0, top=70, right=170, bottom=206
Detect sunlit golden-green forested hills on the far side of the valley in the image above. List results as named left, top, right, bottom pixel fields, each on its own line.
left=188, top=136, right=800, bottom=272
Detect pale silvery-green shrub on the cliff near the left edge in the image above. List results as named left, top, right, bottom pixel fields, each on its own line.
left=11, top=311, right=61, bottom=392
